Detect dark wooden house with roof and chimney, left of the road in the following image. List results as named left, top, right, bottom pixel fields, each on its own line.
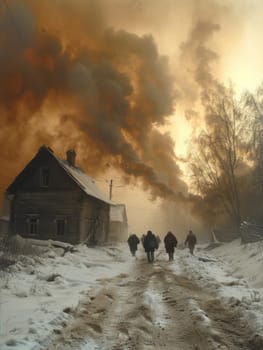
left=6, top=146, right=113, bottom=244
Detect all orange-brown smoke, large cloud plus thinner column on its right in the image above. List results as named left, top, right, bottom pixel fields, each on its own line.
left=0, top=0, right=248, bottom=232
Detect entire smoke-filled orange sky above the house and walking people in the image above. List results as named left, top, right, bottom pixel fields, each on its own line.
left=0, top=0, right=263, bottom=235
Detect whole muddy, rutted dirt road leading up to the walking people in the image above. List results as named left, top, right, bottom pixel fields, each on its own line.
left=45, top=260, right=260, bottom=350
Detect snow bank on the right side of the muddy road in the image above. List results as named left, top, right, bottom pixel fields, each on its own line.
left=172, top=239, right=263, bottom=335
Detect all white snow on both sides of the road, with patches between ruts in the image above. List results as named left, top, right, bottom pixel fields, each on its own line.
left=0, top=240, right=263, bottom=350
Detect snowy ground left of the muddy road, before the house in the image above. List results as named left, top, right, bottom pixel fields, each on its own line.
left=0, top=241, right=132, bottom=350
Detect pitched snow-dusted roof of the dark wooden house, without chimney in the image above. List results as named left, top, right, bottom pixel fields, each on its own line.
left=7, top=146, right=115, bottom=205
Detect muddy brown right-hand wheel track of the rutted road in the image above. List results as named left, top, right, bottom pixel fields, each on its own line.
left=155, top=263, right=261, bottom=350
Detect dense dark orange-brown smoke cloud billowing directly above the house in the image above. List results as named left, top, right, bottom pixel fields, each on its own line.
left=0, top=1, right=186, bottom=202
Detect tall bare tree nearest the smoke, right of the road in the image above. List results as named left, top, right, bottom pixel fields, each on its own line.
left=189, top=89, right=246, bottom=226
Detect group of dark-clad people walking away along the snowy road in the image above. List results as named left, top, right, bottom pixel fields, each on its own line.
left=128, top=230, right=197, bottom=263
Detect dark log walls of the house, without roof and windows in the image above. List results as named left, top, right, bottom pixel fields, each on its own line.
left=9, top=150, right=110, bottom=244
